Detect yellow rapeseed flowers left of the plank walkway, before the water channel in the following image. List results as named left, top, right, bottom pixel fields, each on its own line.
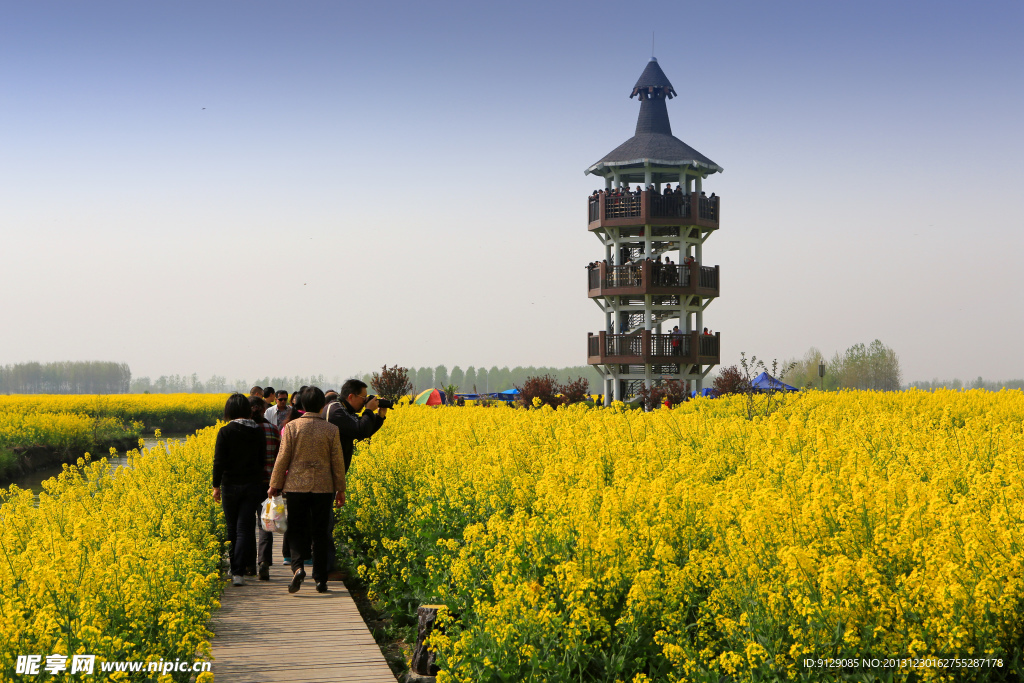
left=0, top=430, right=224, bottom=682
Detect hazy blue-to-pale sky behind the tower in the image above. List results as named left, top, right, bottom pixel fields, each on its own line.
left=0, top=0, right=1024, bottom=380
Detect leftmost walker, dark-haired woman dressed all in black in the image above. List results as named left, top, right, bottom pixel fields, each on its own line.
left=213, top=393, right=266, bottom=586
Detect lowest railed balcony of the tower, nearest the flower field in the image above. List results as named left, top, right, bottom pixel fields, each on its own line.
left=587, top=330, right=722, bottom=366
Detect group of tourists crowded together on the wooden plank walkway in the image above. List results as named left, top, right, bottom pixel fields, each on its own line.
left=207, top=379, right=388, bottom=593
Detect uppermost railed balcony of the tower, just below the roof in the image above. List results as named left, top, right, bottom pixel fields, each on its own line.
left=587, top=189, right=722, bottom=230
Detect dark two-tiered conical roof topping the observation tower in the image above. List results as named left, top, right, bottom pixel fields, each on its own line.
left=585, top=57, right=723, bottom=176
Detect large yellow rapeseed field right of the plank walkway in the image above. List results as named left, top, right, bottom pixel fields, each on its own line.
left=336, top=391, right=1024, bottom=683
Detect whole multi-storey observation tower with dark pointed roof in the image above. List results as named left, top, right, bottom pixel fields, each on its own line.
left=586, top=57, right=723, bottom=404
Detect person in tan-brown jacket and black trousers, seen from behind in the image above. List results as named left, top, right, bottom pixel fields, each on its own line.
left=267, top=387, right=345, bottom=593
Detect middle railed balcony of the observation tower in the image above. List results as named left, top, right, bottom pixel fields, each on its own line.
left=587, top=260, right=719, bottom=298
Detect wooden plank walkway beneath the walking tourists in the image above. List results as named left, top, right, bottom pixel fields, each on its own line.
left=210, top=533, right=395, bottom=683
